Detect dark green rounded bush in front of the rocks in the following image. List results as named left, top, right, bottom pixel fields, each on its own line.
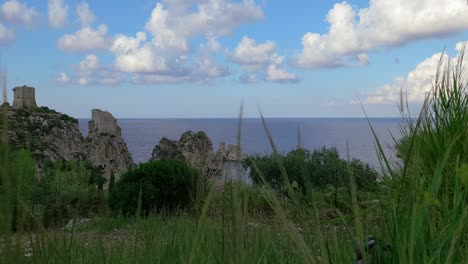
left=109, top=160, right=208, bottom=215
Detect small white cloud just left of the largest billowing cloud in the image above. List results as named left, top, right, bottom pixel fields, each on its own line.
left=57, top=25, right=111, bottom=52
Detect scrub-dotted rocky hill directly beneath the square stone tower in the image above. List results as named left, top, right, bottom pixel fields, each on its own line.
left=8, top=107, right=84, bottom=168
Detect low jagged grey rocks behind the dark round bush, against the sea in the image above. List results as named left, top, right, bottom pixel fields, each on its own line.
left=151, top=131, right=243, bottom=176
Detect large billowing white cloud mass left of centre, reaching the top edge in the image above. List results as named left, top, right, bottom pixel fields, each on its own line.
left=110, top=0, right=263, bottom=83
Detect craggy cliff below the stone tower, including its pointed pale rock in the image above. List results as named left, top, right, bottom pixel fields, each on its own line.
left=4, top=105, right=133, bottom=182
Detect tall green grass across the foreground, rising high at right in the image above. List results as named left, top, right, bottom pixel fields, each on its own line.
left=0, top=48, right=468, bottom=263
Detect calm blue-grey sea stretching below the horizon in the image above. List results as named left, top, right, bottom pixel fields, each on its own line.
left=79, top=118, right=400, bottom=166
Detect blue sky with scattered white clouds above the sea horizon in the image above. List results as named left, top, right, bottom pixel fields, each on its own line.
left=0, top=0, right=468, bottom=118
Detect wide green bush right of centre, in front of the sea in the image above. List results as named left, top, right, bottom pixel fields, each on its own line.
left=246, top=147, right=378, bottom=192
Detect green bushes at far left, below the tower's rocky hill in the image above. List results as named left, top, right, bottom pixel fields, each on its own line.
left=0, top=150, right=106, bottom=231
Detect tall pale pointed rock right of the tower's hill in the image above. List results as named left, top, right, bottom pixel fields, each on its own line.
left=85, top=109, right=133, bottom=180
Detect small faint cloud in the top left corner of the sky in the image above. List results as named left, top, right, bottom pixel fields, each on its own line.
left=0, top=0, right=39, bottom=26
